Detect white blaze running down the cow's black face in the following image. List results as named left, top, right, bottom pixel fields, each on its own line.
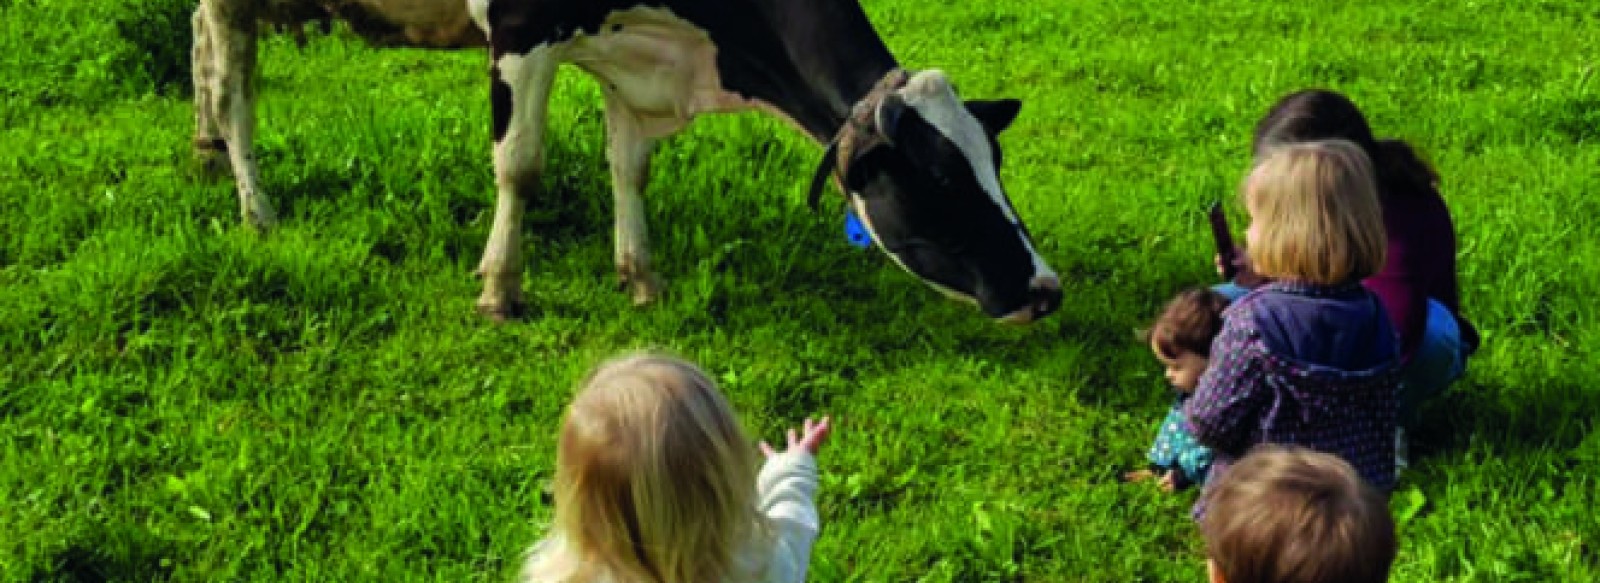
left=898, top=69, right=1056, bottom=279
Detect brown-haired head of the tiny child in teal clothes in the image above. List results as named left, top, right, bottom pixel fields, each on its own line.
left=1147, top=287, right=1227, bottom=392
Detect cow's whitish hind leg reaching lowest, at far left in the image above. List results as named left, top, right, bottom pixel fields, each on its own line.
left=200, top=0, right=275, bottom=229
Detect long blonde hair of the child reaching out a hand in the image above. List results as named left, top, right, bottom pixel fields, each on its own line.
left=522, top=354, right=770, bottom=583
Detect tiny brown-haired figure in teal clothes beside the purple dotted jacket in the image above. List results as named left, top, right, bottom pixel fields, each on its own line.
left=1123, top=287, right=1227, bottom=492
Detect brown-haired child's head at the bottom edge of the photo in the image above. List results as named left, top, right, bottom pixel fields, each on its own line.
left=1200, top=445, right=1397, bottom=583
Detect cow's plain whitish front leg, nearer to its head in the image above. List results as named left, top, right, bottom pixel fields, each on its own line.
left=605, top=90, right=662, bottom=306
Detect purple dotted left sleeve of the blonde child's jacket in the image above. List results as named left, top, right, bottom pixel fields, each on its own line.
left=1184, top=314, right=1270, bottom=456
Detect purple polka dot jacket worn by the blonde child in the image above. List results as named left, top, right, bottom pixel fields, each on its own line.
left=1184, top=282, right=1400, bottom=517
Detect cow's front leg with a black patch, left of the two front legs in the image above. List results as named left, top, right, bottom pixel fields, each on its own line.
left=478, top=47, right=558, bottom=322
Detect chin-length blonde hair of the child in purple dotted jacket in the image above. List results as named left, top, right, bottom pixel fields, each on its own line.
left=1240, top=139, right=1387, bottom=285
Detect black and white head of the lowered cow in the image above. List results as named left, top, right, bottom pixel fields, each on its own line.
left=810, top=69, right=1061, bottom=324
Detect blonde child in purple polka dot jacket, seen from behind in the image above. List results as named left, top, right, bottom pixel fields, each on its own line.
left=1184, top=139, right=1400, bottom=517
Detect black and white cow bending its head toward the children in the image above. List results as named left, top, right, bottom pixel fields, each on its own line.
left=195, top=0, right=1061, bottom=324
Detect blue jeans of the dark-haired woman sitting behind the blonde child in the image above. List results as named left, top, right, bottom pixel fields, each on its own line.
left=1211, top=282, right=1467, bottom=426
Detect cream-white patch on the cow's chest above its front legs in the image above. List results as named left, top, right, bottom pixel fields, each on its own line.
left=562, top=8, right=774, bottom=138
